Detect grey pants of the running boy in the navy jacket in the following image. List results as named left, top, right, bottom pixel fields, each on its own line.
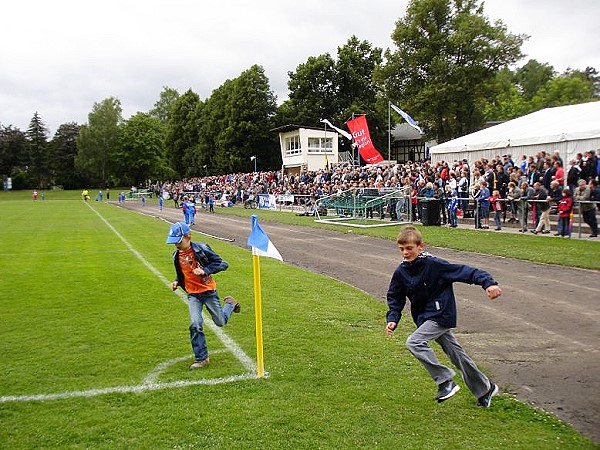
left=406, top=320, right=491, bottom=398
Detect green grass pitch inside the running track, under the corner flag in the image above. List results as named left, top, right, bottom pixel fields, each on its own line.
left=0, top=192, right=597, bottom=449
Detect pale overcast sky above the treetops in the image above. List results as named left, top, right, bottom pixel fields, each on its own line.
left=0, top=0, right=600, bottom=137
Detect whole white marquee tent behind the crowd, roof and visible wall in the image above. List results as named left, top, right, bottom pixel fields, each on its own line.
left=430, top=101, right=600, bottom=164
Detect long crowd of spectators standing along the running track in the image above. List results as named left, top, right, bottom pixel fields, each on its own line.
left=146, top=150, right=600, bottom=237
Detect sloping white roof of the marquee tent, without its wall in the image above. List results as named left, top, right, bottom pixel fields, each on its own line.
left=430, top=102, right=600, bottom=153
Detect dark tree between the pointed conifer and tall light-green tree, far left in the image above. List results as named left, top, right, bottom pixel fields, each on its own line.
left=50, top=122, right=81, bottom=189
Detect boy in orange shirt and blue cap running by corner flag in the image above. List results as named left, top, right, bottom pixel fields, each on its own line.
left=167, top=222, right=241, bottom=369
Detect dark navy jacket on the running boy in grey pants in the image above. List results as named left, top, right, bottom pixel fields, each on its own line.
left=386, top=252, right=498, bottom=328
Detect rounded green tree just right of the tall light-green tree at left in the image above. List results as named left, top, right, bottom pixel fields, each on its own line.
left=114, top=113, right=172, bottom=186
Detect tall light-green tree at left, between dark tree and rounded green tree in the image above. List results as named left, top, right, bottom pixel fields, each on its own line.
left=75, top=97, right=123, bottom=185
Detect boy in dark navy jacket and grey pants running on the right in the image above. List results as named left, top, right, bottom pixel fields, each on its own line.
left=386, top=226, right=502, bottom=408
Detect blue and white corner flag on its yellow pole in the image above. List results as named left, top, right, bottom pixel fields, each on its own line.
left=247, top=214, right=283, bottom=378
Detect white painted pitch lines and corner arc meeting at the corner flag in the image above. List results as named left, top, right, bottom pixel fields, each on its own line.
left=0, top=204, right=256, bottom=403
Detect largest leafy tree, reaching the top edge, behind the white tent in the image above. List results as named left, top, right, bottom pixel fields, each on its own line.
left=379, top=0, right=526, bottom=142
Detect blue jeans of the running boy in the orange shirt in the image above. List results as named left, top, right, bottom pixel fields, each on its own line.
left=188, top=291, right=235, bottom=361
